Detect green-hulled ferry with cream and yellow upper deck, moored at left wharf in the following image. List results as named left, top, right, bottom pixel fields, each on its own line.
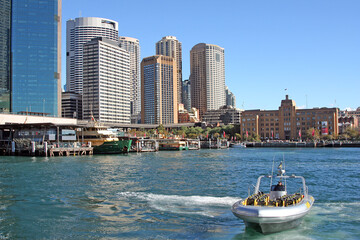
left=81, top=124, right=132, bottom=154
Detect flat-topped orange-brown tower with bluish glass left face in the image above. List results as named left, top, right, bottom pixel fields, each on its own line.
left=141, top=55, right=178, bottom=124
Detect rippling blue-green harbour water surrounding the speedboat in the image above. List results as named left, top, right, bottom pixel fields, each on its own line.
left=0, top=148, right=360, bottom=239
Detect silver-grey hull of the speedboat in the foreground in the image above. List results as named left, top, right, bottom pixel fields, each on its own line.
left=232, top=196, right=314, bottom=234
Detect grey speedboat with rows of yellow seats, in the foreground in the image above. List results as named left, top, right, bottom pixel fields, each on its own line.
left=231, top=162, right=315, bottom=234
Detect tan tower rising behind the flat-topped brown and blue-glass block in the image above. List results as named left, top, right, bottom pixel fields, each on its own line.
left=156, top=36, right=182, bottom=103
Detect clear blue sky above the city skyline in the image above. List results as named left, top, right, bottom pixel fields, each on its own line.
left=62, top=0, right=360, bottom=110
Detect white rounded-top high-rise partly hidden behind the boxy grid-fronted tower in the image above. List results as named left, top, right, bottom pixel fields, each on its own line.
left=66, top=17, right=119, bottom=94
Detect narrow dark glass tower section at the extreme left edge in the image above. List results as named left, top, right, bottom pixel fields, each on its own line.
left=0, top=0, right=11, bottom=112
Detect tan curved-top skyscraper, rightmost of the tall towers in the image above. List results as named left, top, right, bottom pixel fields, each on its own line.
left=190, top=43, right=226, bottom=118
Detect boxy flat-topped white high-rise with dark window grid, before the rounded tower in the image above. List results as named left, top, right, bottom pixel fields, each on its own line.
left=83, top=37, right=130, bottom=124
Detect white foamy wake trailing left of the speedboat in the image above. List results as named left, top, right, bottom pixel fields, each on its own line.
left=118, top=192, right=240, bottom=217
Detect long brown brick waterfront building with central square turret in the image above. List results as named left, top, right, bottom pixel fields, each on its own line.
left=240, top=95, right=339, bottom=140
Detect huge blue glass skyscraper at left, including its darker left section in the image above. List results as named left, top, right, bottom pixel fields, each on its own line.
left=0, top=0, right=61, bottom=116
